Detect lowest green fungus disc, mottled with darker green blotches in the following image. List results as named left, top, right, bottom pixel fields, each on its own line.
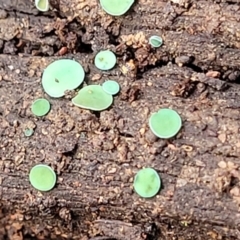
left=133, top=168, right=161, bottom=198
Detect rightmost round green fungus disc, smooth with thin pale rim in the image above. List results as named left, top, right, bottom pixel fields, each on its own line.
left=149, top=108, right=182, bottom=139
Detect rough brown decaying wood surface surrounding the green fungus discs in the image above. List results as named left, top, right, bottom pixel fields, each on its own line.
left=0, top=0, right=240, bottom=240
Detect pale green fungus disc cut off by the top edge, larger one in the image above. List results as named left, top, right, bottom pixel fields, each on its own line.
left=100, top=0, right=134, bottom=16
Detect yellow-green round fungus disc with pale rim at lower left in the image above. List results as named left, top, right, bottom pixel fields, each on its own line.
left=29, top=164, right=57, bottom=192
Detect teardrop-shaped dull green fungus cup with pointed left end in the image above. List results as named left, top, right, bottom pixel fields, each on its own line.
left=72, top=85, right=113, bottom=111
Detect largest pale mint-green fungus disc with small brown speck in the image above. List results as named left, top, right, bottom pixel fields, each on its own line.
left=42, top=59, right=85, bottom=98
